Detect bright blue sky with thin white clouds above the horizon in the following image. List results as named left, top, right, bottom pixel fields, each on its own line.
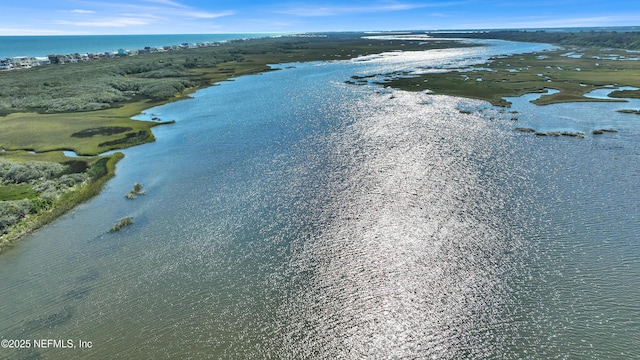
left=0, top=0, right=640, bottom=35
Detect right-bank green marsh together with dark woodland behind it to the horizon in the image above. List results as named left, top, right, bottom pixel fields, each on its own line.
left=381, top=31, right=640, bottom=107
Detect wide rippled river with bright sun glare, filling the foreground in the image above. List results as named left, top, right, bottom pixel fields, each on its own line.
left=0, top=42, right=640, bottom=359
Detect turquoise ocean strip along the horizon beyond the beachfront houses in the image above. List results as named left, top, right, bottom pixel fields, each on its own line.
left=0, top=33, right=279, bottom=59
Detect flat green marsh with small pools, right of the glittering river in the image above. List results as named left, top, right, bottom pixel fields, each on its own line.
left=384, top=49, right=640, bottom=107
